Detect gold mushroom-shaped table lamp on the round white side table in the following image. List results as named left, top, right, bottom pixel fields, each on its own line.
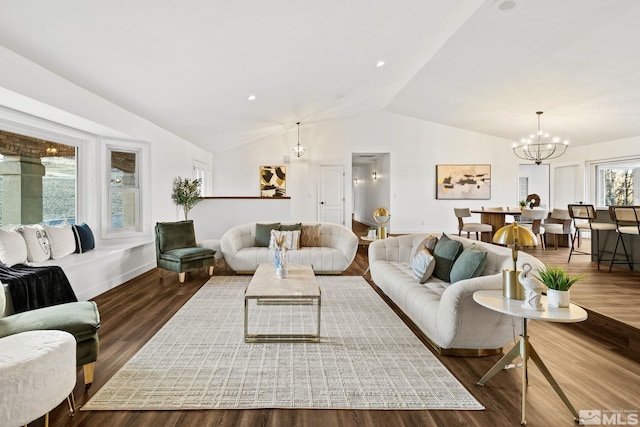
left=493, top=222, right=538, bottom=300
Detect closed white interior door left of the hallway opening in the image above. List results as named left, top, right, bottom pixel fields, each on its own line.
left=318, top=165, right=345, bottom=225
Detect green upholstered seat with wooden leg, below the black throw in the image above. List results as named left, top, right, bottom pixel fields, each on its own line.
left=0, top=301, right=100, bottom=388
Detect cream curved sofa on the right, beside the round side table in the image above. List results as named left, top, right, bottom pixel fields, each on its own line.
left=369, top=234, right=544, bottom=355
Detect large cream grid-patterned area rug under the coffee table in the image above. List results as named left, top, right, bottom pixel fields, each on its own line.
left=82, top=276, right=484, bottom=410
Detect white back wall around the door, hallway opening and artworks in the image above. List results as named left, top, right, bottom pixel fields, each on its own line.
left=213, top=112, right=519, bottom=233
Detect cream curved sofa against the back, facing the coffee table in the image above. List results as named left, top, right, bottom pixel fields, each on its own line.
left=220, top=222, right=358, bottom=274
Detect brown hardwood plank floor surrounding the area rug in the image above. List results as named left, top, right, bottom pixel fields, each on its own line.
left=40, top=226, right=640, bottom=427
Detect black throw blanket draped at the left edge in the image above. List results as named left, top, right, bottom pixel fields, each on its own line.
left=0, top=264, right=78, bottom=313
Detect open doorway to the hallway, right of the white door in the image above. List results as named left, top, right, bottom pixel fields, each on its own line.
left=351, top=153, right=393, bottom=232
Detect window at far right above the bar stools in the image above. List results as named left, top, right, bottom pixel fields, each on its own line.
left=595, top=158, right=640, bottom=206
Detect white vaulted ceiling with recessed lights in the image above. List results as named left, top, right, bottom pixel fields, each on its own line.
left=0, top=0, right=640, bottom=151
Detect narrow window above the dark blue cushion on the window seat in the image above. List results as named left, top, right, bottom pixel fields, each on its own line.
left=109, top=150, right=140, bottom=231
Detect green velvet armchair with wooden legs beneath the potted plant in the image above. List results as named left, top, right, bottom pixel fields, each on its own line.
left=156, top=220, right=215, bottom=284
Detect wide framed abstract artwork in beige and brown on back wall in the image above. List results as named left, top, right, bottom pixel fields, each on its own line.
left=436, top=165, right=491, bottom=200
